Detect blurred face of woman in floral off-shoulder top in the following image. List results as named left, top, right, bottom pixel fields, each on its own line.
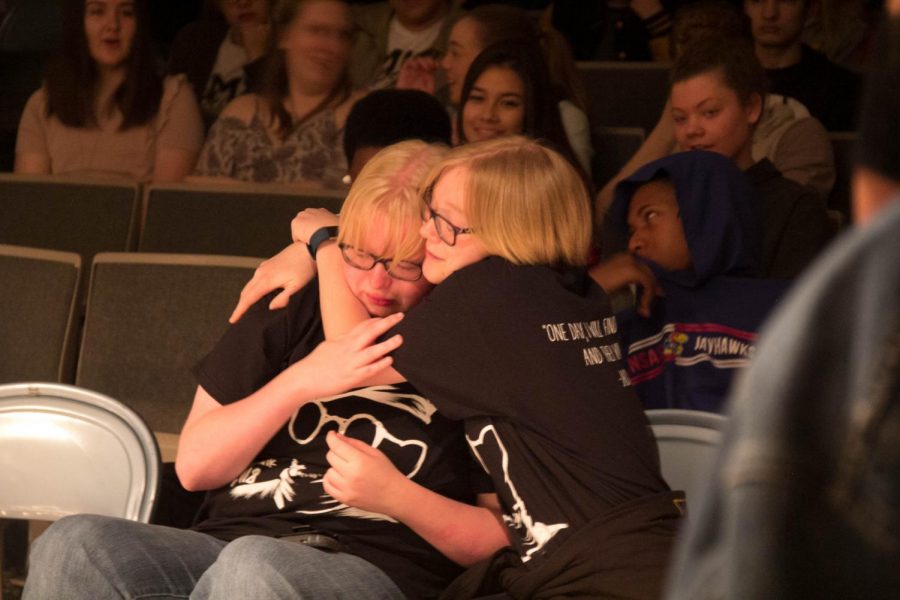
left=279, top=0, right=353, bottom=94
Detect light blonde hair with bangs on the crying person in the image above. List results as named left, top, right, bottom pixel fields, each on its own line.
left=338, top=140, right=447, bottom=261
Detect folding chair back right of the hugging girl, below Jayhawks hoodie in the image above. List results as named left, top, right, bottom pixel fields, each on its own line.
left=646, top=408, right=727, bottom=503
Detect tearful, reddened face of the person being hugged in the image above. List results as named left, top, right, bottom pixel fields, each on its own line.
left=344, top=215, right=432, bottom=317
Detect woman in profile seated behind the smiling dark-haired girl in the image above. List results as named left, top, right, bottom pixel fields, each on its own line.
left=397, top=4, right=594, bottom=174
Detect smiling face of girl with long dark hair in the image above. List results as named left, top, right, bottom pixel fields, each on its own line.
left=462, top=66, right=525, bottom=142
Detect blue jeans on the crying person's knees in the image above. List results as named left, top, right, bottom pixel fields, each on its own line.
left=23, top=515, right=404, bottom=600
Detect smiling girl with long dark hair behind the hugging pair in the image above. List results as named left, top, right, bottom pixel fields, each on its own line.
left=457, top=42, right=586, bottom=172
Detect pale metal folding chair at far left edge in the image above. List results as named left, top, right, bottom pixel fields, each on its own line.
left=0, top=383, right=160, bottom=523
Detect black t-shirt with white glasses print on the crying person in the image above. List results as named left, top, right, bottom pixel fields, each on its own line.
left=193, top=281, right=486, bottom=598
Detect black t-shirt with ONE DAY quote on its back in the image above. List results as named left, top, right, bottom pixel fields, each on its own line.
left=394, top=257, right=668, bottom=562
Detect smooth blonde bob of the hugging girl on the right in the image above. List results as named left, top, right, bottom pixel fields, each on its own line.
left=425, top=136, right=592, bottom=265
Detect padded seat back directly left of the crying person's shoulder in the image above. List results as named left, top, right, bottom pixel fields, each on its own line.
left=75, top=252, right=261, bottom=433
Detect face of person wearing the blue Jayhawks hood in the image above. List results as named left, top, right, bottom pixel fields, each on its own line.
left=628, top=180, right=691, bottom=271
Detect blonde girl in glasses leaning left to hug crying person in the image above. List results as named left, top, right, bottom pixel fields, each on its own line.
left=236, top=136, right=683, bottom=598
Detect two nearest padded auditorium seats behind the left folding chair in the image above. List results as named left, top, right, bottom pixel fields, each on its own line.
left=0, top=245, right=260, bottom=460
